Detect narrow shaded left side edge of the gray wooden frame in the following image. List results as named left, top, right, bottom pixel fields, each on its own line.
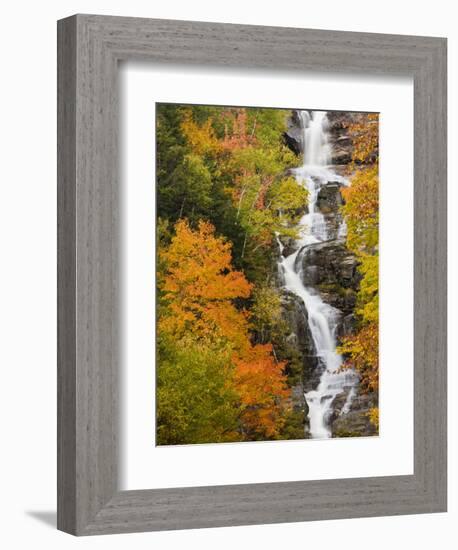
left=57, top=18, right=76, bottom=532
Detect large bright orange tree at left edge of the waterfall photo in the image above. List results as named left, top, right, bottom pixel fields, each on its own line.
left=159, top=220, right=251, bottom=342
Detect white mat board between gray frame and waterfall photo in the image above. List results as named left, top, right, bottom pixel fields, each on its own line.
left=121, top=63, right=413, bottom=489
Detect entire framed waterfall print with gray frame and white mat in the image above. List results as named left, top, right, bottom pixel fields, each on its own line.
left=58, top=15, right=446, bottom=535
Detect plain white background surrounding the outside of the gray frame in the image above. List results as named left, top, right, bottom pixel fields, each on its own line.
left=0, top=0, right=458, bottom=550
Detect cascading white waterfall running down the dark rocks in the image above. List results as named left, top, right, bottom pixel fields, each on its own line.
left=279, top=111, right=358, bottom=438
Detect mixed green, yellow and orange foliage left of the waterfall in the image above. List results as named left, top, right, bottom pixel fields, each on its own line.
left=157, top=104, right=307, bottom=445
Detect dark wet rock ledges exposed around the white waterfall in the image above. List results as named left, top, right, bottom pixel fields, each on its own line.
left=279, top=111, right=377, bottom=437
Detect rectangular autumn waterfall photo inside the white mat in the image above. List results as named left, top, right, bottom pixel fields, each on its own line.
left=157, top=103, right=379, bottom=446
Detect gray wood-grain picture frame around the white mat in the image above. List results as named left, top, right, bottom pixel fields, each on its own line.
left=58, top=15, right=447, bottom=535
